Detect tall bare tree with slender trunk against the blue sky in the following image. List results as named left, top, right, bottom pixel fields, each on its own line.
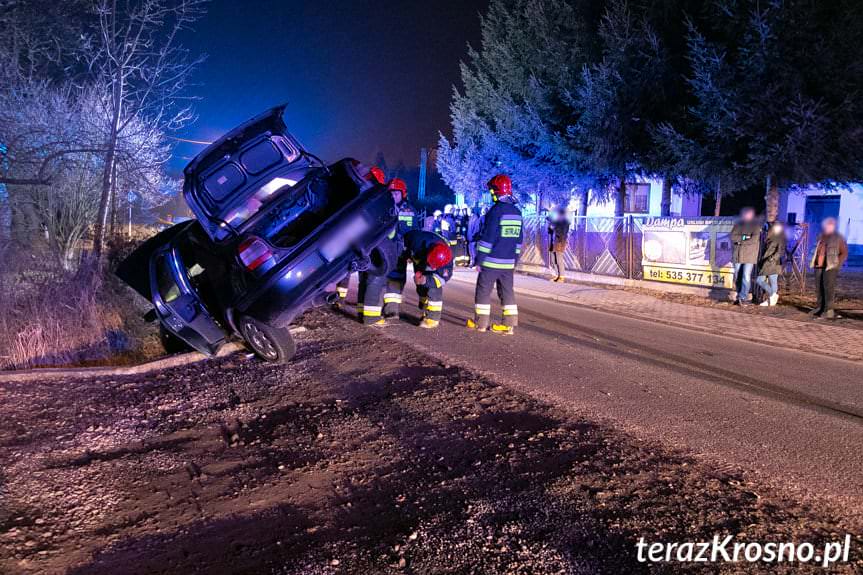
left=84, top=0, right=205, bottom=258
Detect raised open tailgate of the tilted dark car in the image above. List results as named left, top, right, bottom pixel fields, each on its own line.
left=183, top=106, right=320, bottom=243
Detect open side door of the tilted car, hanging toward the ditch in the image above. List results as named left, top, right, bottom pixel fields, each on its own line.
left=150, top=243, right=227, bottom=355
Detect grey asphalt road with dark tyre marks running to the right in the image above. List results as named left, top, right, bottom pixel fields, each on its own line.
left=348, top=274, right=863, bottom=516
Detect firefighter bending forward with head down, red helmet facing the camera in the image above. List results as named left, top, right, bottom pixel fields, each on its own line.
left=404, top=230, right=460, bottom=329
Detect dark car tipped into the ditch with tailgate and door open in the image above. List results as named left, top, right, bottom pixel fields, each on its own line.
left=116, top=106, right=397, bottom=362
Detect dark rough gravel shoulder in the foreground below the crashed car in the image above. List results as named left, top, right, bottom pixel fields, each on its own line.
left=0, top=312, right=863, bottom=575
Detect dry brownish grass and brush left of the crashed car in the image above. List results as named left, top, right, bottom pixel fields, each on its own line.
left=0, top=242, right=159, bottom=369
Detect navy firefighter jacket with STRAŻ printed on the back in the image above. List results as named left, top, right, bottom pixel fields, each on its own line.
left=476, top=196, right=522, bottom=270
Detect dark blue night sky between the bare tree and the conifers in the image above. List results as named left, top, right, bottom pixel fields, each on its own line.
left=174, top=0, right=488, bottom=168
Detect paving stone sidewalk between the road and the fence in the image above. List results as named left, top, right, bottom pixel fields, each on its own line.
left=453, top=269, right=863, bottom=361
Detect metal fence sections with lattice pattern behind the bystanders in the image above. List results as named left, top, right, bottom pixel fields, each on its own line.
left=521, top=214, right=809, bottom=291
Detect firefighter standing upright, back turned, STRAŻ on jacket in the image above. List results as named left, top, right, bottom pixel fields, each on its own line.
left=467, top=174, right=522, bottom=335
